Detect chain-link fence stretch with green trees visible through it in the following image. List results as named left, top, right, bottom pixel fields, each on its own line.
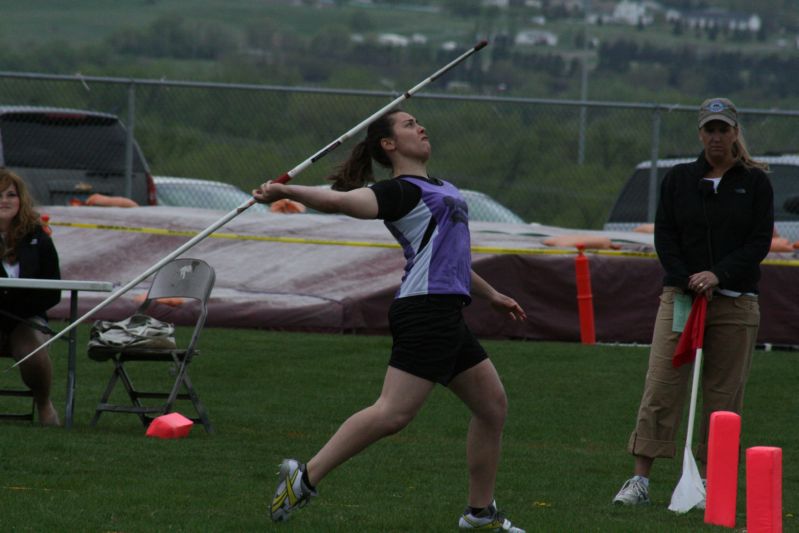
left=0, top=72, right=799, bottom=229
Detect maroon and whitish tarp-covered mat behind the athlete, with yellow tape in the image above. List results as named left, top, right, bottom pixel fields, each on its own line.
left=41, top=206, right=799, bottom=345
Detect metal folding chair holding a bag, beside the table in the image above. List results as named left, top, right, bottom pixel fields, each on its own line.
left=89, top=259, right=215, bottom=433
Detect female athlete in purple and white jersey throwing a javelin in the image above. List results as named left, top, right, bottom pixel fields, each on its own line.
left=253, top=109, right=527, bottom=533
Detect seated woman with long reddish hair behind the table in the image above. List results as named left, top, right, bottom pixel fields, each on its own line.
left=0, top=168, right=61, bottom=425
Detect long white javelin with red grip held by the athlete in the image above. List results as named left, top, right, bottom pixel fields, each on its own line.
left=6, top=40, right=488, bottom=372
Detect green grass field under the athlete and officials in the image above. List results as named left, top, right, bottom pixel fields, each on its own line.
left=0, top=324, right=799, bottom=533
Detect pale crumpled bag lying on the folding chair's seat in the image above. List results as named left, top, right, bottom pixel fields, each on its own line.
left=89, top=313, right=177, bottom=350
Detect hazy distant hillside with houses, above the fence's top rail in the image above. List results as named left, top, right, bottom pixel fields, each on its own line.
left=0, top=0, right=799, bottom=105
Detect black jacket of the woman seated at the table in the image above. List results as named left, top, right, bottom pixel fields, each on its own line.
left=0, top=222, right=61, bottom=329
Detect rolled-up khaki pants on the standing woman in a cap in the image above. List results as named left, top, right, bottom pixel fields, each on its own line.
left=627, top=287, right=760, bottom=463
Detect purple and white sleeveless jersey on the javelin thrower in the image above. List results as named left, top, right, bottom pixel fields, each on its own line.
left=384, top=176, right=472, bottom=298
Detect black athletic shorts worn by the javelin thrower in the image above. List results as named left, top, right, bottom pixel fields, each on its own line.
left=388, top=294, right=488, bottom=385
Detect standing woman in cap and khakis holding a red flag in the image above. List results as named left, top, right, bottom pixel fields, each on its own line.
left=613, top=98, right=774, bottom=507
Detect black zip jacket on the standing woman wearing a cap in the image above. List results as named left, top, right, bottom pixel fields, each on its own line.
left=655, top=152, right=774, bottom=293
